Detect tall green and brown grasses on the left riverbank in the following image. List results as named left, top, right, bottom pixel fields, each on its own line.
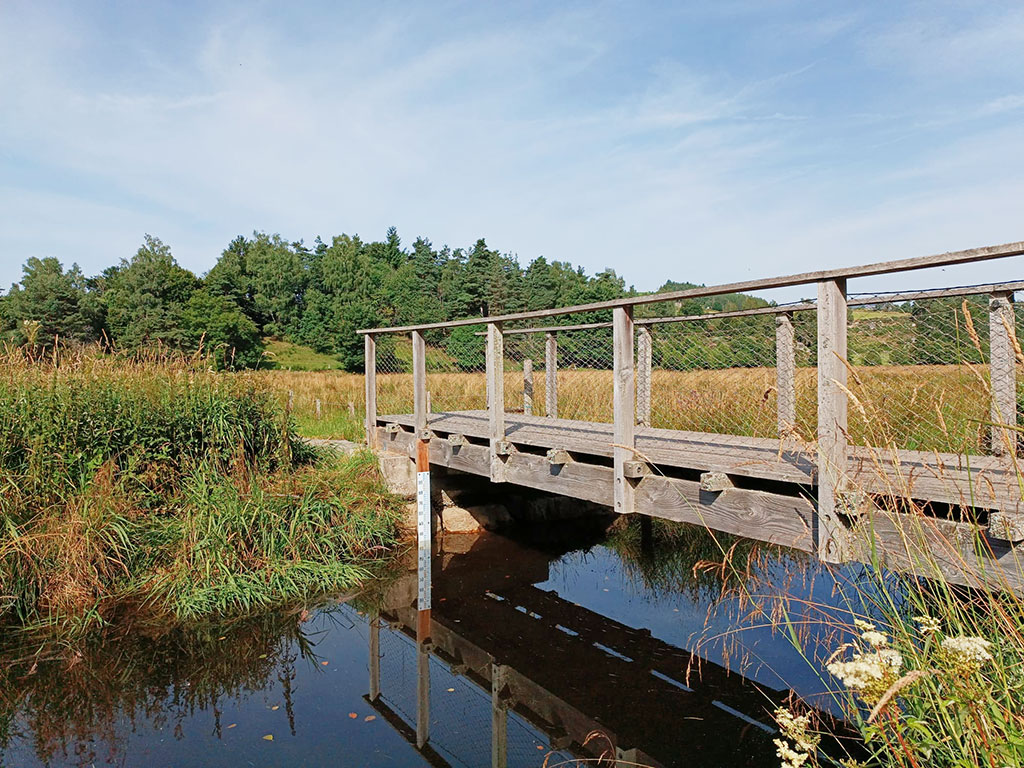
left=0, top=348, right=397, bottom=629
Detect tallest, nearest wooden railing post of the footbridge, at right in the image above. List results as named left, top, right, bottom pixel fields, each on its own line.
left=815, top=279, right=848, bottom=562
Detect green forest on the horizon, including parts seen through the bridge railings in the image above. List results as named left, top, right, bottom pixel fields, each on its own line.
left=0, top=227, right=987, bottom=371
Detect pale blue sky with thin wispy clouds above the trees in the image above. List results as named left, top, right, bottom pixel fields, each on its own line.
left=0, top=0, right=1024, bottom=290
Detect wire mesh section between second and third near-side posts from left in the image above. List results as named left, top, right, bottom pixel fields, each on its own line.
left=424, top=326, right=487, bottom=421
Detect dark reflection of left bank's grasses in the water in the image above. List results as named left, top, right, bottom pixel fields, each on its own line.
left=0, top=608, right=364, bottom=765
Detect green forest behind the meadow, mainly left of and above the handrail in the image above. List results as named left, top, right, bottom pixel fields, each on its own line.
left=0, top=227, right=764, bottom=371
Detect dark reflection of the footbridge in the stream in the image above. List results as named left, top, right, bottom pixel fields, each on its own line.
left=369, top=538, right=786, bottom=766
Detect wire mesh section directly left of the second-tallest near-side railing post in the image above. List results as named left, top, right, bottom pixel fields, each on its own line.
left=556, top=328, right=613, bottom=424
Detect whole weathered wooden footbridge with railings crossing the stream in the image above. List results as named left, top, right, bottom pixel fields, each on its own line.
left=359, top=243, right=1024, bottom=590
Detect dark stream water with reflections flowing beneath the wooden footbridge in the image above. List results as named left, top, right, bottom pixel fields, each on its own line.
left=0, top=520, right=864, bottom=768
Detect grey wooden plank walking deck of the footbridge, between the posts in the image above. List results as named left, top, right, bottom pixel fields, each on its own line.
left=378, top=411, right=1024, bottom=511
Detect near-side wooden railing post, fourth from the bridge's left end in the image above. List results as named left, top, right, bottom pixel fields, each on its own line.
left=611, top=306, right=636, bottom=514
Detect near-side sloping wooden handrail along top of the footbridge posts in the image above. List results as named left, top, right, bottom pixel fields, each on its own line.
left=356, top=241, right=1024, bottom=334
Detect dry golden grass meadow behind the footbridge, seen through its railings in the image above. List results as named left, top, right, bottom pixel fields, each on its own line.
left=251, top=365, right=1007, bottom=453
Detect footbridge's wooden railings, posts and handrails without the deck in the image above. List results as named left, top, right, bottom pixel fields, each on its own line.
left=359, top=243, right=1024, bottom=560
